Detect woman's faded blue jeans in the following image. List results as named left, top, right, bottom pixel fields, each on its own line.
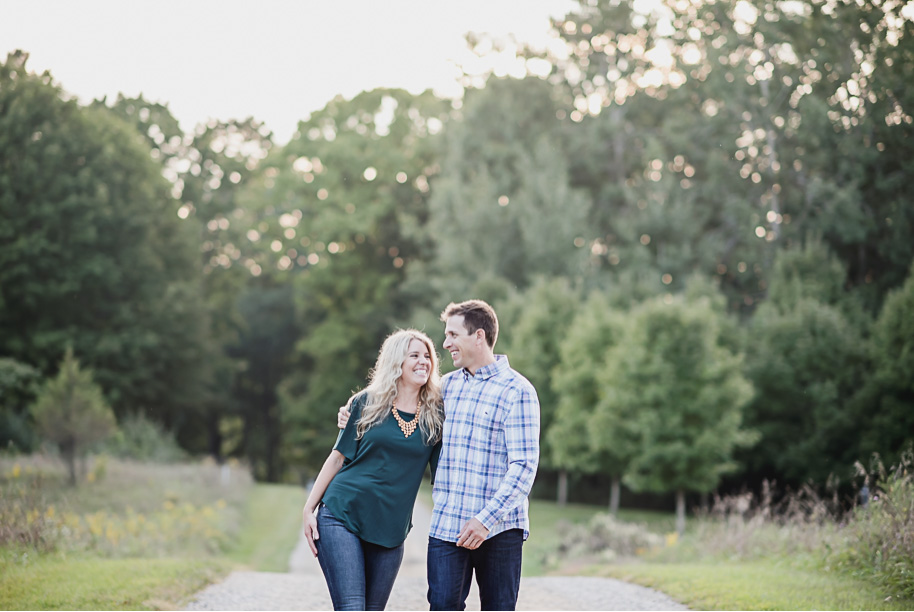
left=315, top=505, right=403, bottom=610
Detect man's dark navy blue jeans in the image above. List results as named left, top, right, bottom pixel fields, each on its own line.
left=428, top=529, right=524, bottom=610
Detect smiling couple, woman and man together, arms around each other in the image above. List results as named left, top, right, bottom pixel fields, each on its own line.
left=303, top=300, right=540, bottom=610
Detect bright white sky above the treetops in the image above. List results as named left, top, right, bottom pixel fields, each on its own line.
left=7, top=0, right=574, bottom=143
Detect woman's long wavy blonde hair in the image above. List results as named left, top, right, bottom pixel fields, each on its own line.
left=356, top=329, right=444, bottom=444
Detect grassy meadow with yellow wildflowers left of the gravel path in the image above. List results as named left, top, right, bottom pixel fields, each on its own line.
left=0, top=458, right=305, bottom=610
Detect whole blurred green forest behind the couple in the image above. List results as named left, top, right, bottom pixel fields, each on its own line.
left=0, top=0, right=914, bottom=508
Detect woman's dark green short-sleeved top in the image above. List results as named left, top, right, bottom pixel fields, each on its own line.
left=318, top=393, right=441, bottom=548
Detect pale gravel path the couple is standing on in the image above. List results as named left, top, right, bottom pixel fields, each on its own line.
left=186, top=501, right=688, bottom=610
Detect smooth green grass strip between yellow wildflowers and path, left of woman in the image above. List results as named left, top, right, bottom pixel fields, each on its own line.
left=229, top=484, right=306, bottom=572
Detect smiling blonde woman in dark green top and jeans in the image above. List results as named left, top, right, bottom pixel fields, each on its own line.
left=303, top=329, right=444, bottom=610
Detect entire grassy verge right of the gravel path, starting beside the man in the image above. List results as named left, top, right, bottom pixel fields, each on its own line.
left=523, top=490, right=912, bottom=610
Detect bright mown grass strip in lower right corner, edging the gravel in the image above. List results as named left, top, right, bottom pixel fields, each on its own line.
left=587, top=559, right=911, bottom=610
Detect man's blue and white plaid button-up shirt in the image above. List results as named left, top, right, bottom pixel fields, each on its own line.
left=429, top=355, right=540, bottom=542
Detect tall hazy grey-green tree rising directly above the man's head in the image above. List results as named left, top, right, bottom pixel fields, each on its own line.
left=411, top=78, right=590, bottom=303
